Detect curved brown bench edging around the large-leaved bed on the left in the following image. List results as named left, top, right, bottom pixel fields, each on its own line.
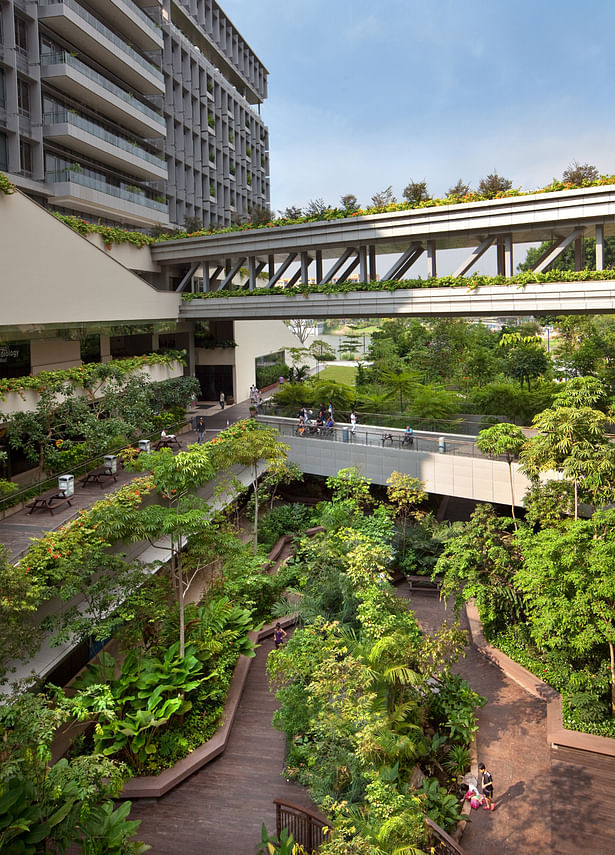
left=118, top=614, right=297, bottom=799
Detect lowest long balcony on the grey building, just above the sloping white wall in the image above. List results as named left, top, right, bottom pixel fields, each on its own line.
left=45, top=168, right=169, bottom=226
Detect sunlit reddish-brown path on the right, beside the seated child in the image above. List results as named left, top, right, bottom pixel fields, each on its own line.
left=397, top=583, right=552, bottom=855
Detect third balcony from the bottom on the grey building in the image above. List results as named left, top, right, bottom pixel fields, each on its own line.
left=41, top=51, right=166, bottom=138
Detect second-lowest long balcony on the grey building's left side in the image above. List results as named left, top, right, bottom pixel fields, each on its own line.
left=43, top=107, right=168, bottom=181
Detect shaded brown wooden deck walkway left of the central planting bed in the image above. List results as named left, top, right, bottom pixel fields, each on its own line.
left=130, top=639, right=314, bottom=855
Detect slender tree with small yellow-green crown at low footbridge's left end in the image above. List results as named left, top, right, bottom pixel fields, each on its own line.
left=210, top=420, right=288, bottom=555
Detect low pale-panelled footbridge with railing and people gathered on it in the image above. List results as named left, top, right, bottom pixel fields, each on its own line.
left=258, top=416, right=532, bottom=507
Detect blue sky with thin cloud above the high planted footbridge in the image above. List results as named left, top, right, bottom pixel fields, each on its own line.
left=219, top=0, right=615, bottom=212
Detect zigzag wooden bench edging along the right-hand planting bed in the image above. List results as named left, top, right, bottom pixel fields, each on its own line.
left=466, top=600, right=615, bottom=757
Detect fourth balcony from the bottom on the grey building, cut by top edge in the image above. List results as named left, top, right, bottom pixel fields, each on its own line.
left=38, top=0, right=164, bottom=95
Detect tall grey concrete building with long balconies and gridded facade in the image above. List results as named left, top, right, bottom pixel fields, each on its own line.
left=0, top=0, right=269, bottom=228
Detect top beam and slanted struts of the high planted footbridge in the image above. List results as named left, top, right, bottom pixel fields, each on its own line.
left=152, top=185, right=615, bottom=298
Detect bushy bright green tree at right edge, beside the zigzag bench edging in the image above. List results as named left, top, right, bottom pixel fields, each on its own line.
left=516, top=511, right=615, bottom=715
